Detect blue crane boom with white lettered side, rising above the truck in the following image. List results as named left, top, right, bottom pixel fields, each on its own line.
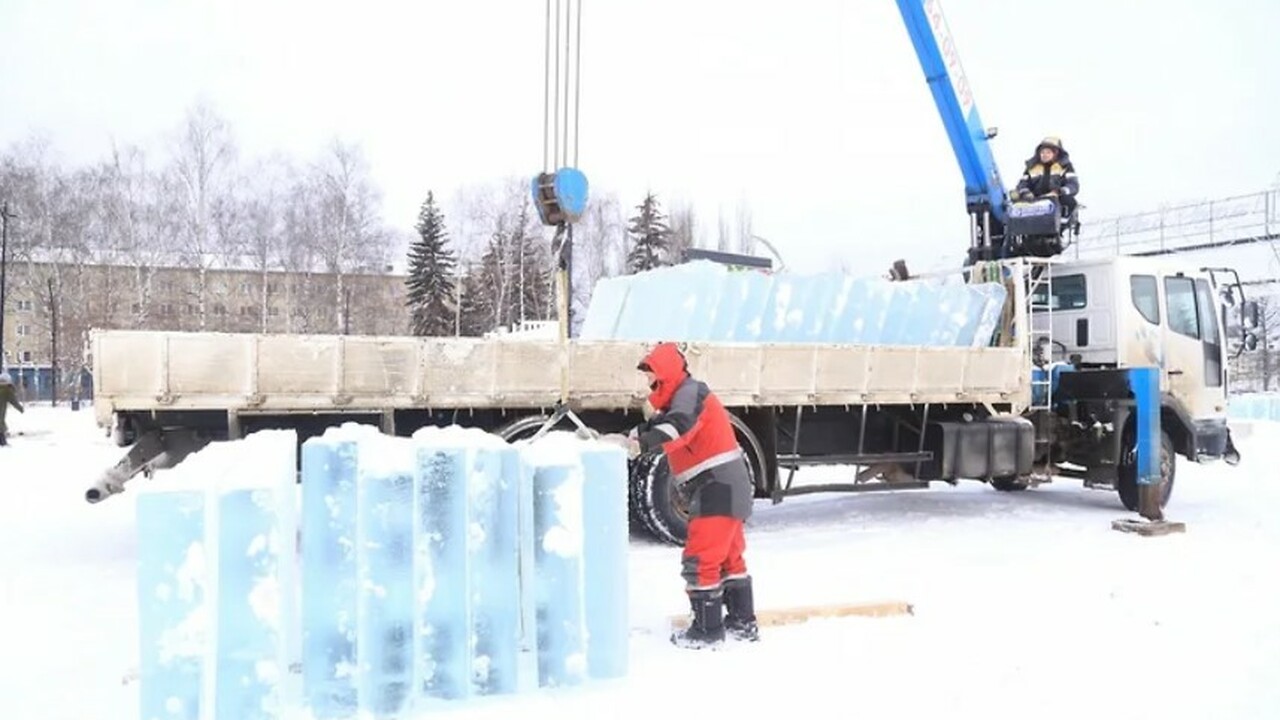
left=897, top=0, right=1006, bottom=224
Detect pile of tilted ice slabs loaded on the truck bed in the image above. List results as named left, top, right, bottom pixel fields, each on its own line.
left=579, top=260, right=1006, bottom=346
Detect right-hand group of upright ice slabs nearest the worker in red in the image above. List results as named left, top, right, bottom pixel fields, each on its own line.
left=302, top=425, right=627, bottom=719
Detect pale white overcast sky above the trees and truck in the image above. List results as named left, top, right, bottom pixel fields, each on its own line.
left=0, top=0, right=1280, bottom=273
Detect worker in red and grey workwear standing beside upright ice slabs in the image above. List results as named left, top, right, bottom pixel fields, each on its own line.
left=631, top=342, right=758, bottom=647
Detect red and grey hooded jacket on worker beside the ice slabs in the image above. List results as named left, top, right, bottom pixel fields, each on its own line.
left=639, top=342, right=754, bottom=519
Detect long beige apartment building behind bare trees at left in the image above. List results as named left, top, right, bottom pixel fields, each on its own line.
left=4, top=261, right=410, bottom=400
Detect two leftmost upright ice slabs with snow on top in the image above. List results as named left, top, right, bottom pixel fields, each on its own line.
left=138, top=430, right=297, bottom=719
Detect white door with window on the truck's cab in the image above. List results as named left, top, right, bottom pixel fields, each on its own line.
left=1164, top=275, right=1226, bottom=421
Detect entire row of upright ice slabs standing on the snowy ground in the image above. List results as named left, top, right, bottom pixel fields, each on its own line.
left=138, top=424, right=628, bottom=720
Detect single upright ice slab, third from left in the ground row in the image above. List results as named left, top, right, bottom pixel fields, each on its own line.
left=301, top=423, right=378, bottom=720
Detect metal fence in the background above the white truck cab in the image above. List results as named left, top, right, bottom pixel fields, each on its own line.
left=1068, top=188, right=1280, bottom=259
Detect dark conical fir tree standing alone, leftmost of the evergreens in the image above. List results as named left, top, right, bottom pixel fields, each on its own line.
left=404, top=192, right=457, bottom=336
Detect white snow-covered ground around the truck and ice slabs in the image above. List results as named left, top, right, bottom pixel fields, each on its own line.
left=0, top=406, right=1280, bottom=720
